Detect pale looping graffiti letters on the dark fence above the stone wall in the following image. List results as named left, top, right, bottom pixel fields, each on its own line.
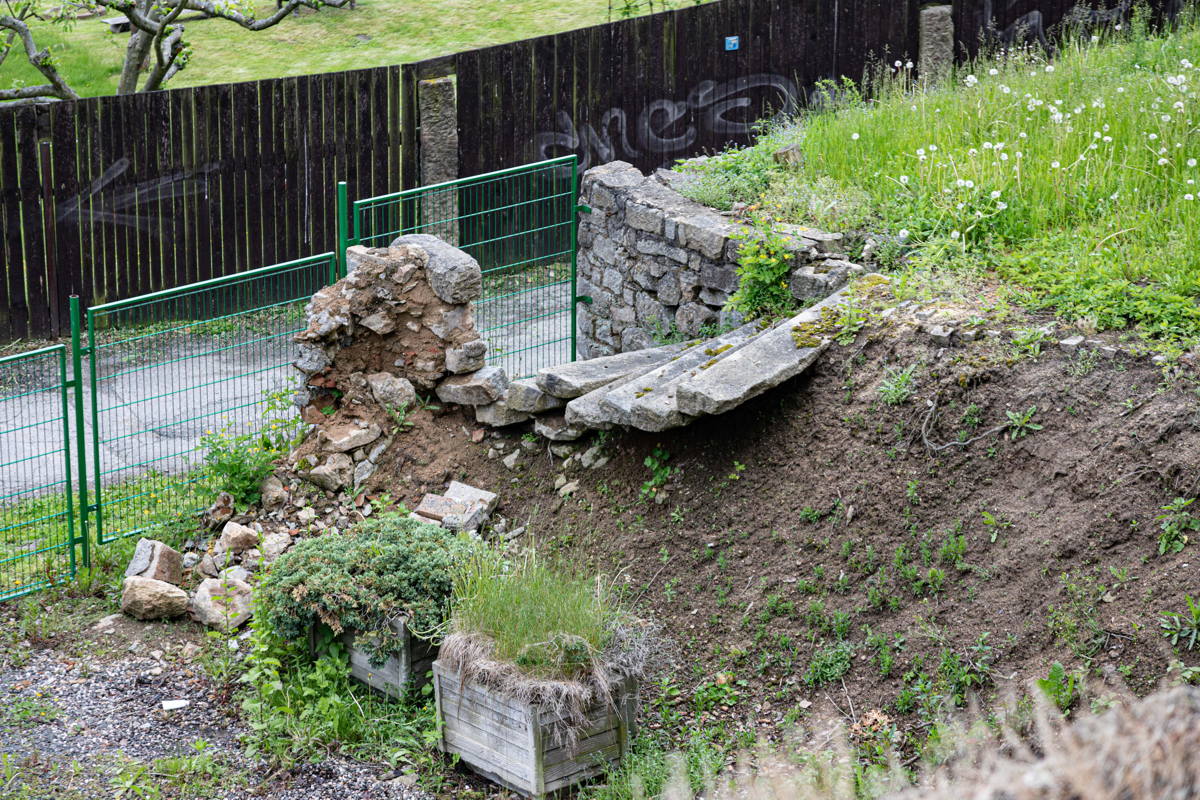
left=534, top=73, right=799, bottom=170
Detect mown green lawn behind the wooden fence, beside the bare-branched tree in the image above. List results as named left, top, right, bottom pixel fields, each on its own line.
left=0, top=0, right=662, bottom=96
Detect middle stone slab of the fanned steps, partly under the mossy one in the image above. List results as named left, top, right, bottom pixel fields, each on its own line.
left=600, top=323, right=763, bottom=431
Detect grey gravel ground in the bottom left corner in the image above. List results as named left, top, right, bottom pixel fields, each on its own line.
left=0, top=644, right=430, bottom=800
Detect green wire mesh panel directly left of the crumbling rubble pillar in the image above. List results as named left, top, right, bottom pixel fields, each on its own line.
left=86, top=253, right=336, bottom=542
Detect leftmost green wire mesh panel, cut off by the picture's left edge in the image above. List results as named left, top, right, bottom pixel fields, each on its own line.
left=0, top=344, right=76, bottom=601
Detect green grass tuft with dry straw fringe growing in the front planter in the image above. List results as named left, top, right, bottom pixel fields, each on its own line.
left=438, top=551, right=662, bottom=746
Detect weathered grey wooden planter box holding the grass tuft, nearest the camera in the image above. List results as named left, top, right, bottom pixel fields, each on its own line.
left=433, top=661, right=638, bottom=798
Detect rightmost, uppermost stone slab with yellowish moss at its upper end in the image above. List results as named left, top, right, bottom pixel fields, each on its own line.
left=676, top=280, right=873, bottom=416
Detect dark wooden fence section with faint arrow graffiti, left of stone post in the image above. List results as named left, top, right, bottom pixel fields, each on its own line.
left=0, top=67, right=402, bottom=342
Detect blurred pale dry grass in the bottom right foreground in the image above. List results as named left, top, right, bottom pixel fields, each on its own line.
left=662, top=687, right=1200, bottom=800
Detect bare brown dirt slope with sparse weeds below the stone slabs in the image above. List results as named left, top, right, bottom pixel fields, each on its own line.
left=379, top=314, right=1200, bottom=753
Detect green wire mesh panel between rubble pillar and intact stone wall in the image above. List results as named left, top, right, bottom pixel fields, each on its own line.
left=338, top=156, right=584, bottom=378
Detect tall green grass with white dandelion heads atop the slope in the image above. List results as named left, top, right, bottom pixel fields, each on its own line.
left=700, top=8, right=1200, bottom=339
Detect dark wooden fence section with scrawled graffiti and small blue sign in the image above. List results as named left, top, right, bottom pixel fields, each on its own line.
left=406, top=0, right=919, bottom=181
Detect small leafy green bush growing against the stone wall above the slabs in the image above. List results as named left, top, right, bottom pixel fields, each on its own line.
left=728, top=213, right=796, bottom=319
